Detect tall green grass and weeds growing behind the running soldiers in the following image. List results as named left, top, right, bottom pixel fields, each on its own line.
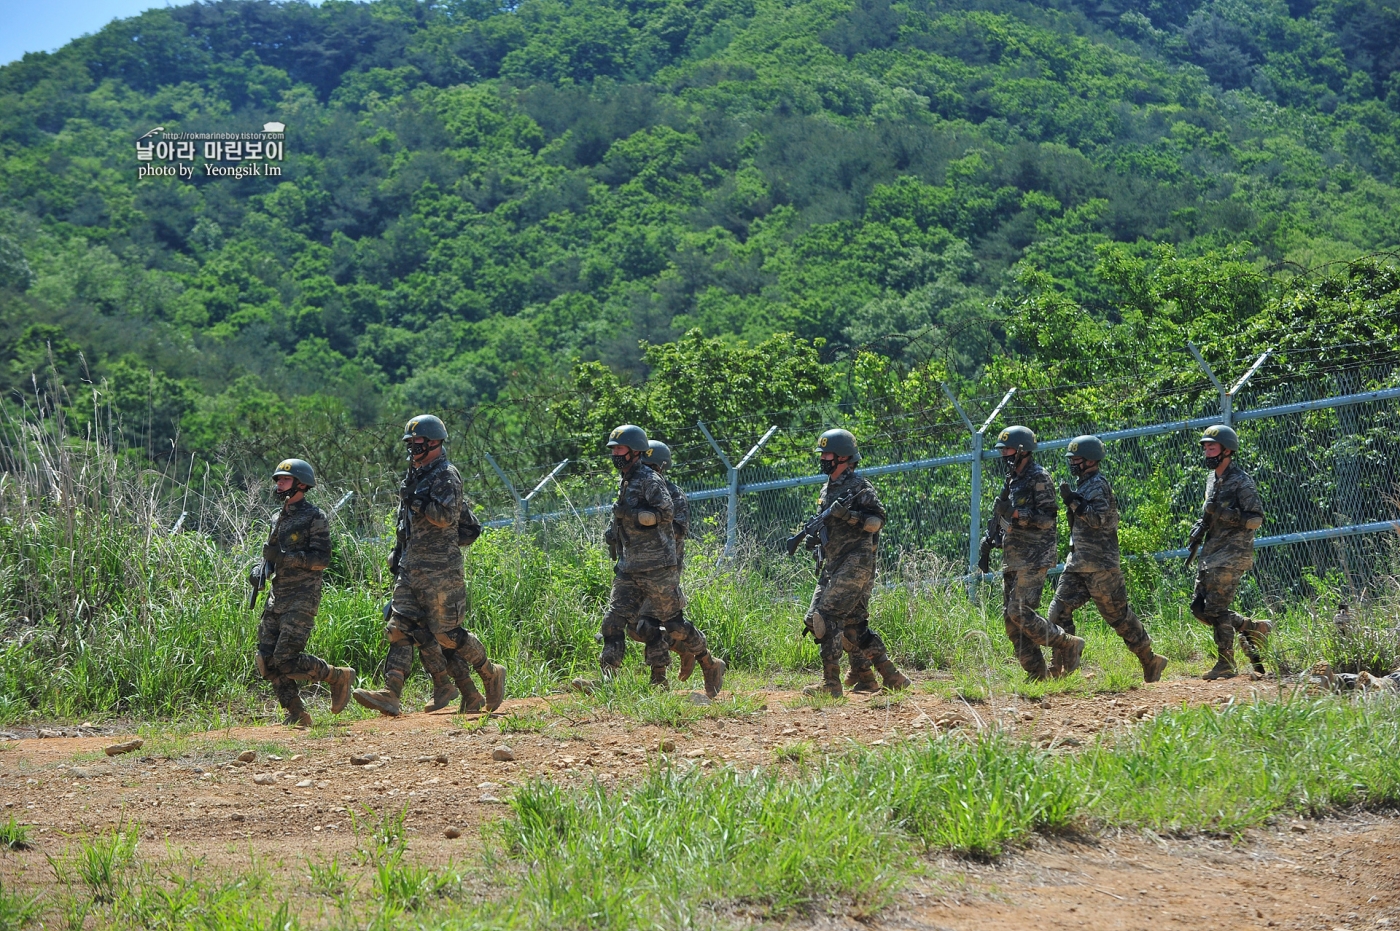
left=0, top=464, right=1400, bottom=732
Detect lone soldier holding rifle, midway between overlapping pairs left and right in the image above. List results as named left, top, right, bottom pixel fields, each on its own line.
left=804, top=430, right=910, bottom=697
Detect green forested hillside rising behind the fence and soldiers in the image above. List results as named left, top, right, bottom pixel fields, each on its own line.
left=0, top=0, right=1400, bottom=467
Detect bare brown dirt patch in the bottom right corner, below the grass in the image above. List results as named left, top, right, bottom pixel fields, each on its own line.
left=890, top=816, right=1400, bottom=931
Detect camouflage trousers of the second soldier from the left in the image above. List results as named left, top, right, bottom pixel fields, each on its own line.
left=385, top=566, right=487, bottom=682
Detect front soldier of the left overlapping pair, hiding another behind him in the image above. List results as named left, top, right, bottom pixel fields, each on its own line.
left=585, top=424, right=725, bottom=697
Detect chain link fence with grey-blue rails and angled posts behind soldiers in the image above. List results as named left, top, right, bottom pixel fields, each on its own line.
left=477, top=354, right=1400, bottom=599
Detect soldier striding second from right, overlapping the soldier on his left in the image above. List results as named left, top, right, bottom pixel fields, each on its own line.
left=1046, top=435, right=1166, bottom=682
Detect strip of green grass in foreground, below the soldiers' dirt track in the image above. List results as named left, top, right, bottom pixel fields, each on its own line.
left=10, top=694, right=1400, bottom=931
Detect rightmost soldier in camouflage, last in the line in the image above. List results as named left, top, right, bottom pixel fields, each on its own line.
left=1187, top=424, right=1273, bottom=679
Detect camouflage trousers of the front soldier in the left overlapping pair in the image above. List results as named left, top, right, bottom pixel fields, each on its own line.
left=599, top=566, right=707, bottom=668
